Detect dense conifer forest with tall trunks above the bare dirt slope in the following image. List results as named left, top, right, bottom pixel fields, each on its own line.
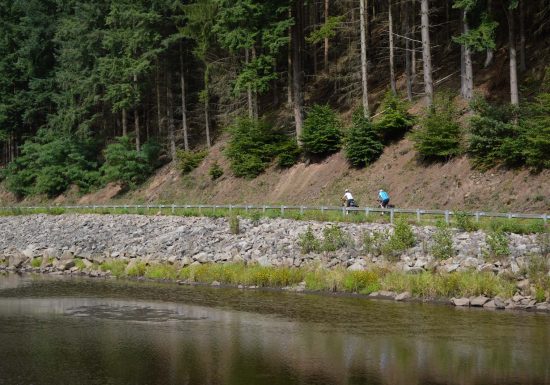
left=0, top=0, right=550, bottom=197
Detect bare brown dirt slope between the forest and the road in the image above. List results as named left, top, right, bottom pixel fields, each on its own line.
left=113, top=139, right=550, bottom=212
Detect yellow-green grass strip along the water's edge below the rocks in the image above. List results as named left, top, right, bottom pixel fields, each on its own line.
left=81, top=261, right=550, bottom=301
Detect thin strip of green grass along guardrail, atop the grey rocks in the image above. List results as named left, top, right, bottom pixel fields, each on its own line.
left=0, top=205, right=548, bottom=234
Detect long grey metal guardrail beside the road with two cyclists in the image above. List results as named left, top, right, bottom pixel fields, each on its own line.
left=0, top=204, right=549, bottom=224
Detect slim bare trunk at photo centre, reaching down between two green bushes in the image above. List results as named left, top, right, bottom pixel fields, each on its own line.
left=292, top=0, right=304, bottom=141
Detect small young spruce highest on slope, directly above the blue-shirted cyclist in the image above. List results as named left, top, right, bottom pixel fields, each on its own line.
left=376, top=91, right=414, bottom=143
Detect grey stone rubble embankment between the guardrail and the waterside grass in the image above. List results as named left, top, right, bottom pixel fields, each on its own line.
left=0, top=215, right=550, bottom=310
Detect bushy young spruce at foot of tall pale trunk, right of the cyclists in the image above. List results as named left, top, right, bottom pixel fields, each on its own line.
left=413, top=94, right=462, bottom=160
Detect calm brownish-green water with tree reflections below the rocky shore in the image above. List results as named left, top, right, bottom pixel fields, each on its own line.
left=0, top=272, right=550, bottom=385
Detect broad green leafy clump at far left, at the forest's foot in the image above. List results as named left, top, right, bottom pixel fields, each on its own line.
left=4, top=129, right=99, bottom=197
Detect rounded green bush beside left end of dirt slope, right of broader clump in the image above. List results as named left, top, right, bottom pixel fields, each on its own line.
left=100, top=136, right=160, bottom=187
